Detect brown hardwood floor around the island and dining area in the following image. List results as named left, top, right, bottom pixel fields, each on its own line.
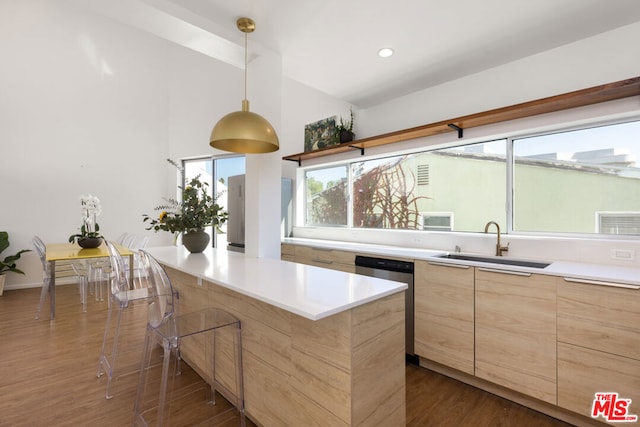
left=0, top=285, right=570, bottom=427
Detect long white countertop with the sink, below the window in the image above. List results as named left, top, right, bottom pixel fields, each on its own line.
left=283, top=238, right=640, bottom=286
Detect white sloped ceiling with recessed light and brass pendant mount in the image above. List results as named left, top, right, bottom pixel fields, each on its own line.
left=76, top=0, right=640, bottom=107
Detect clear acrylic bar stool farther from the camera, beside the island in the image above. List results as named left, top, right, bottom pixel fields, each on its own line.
left=97, top=240, right=151, bottom=399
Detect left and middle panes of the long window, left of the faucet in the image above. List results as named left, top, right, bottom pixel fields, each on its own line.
left=305, top=140, right=506, bottom=231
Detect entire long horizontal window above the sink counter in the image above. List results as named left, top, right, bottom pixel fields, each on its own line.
left=304, top=117, right=640, bottom=235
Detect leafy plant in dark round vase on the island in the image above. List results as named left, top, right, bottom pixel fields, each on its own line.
left=142, top=175, right=228, bottom=253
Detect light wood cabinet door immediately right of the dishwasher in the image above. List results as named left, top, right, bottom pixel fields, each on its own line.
left=414, top=261, right=474, bottom=375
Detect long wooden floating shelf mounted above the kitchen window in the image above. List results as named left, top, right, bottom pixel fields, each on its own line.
left=282, top=77, right=640, bottom=166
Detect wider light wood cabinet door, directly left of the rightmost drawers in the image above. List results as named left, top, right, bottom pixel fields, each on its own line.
left=475, top=268, right=559, bottom=404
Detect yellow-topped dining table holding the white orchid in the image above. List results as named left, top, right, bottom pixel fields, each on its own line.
left=45, top=242, right=134, bottom=320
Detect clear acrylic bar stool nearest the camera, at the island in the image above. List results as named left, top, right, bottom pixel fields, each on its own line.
left=133, top=251, right=246, bottom=426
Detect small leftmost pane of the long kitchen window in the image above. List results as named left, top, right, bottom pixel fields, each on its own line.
left=304, top=166, right=348, bottom=226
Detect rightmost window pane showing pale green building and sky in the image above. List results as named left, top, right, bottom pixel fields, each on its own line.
left=513, top=122, right=640, bottom=235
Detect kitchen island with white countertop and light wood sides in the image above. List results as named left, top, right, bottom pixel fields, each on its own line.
left=148, top=246, right=407, bottom=426
